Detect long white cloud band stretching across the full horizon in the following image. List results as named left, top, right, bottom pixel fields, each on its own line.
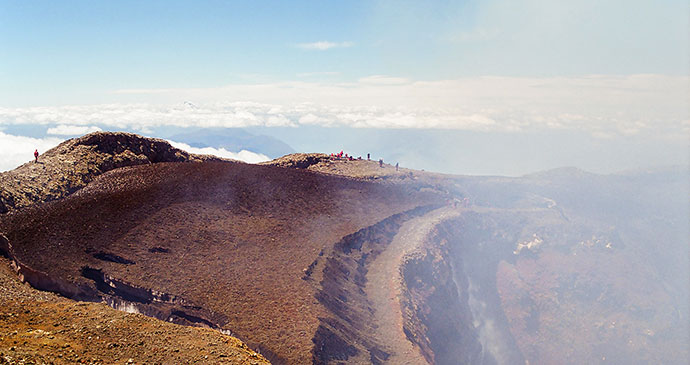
left=0, top=74, right=690, bottom=139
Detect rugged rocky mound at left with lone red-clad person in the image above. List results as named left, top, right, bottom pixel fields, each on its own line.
left=0, top=132, right=226, bottom=214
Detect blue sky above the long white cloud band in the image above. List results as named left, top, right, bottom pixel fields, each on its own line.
left=0, top=0, right=690, bottom=105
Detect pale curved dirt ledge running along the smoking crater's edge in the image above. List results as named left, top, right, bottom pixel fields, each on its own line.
left=365, top=207, right=460, bottom=364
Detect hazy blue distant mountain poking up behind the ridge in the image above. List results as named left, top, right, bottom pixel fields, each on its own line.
left=167, top=128, right=295, bottom=158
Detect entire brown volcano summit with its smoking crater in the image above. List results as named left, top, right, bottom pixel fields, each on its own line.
left=0, top=133, right=688, bottom=364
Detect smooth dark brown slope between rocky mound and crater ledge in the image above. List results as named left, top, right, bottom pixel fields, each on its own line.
left=2, top=141, right=441, bottom=363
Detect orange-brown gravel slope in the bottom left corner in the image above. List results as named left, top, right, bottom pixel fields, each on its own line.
left=0, top=258, right=268, bottom=364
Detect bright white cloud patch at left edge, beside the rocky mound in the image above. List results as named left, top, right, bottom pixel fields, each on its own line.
left=0, top=132, right=63, bottom=171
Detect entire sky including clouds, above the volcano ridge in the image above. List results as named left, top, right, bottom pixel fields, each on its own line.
left=0, top=0, right=690, bottom=175
